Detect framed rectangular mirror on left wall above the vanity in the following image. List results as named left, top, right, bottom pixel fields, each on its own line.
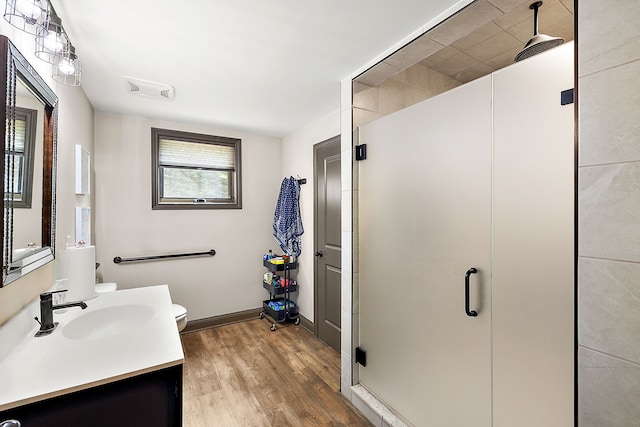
left=0, top=36, right=58, bottom=286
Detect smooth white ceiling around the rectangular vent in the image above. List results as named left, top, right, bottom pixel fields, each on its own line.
left=52, top=0, right=572, bottom=136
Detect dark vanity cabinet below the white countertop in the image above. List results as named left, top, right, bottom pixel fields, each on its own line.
left=0, top=365, right=182, bottom=427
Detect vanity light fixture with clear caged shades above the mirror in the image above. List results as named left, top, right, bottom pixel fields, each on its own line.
left=4, top=0, right=82, bottom=86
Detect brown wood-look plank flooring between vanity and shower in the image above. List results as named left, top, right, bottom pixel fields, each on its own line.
left=181, top=319, right=372, bottom=427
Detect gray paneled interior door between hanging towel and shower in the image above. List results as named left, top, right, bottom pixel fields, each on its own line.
left=314, top=136, right=342, bottom=351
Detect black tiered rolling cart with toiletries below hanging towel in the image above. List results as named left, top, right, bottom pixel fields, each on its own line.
left=260, top=259, right=300, bottom=331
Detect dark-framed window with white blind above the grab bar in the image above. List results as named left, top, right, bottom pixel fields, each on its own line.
left=151, top=128, right=242, bottom=209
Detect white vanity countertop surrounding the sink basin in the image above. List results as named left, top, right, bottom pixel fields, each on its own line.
left=0, top=285, right=184, bottom=411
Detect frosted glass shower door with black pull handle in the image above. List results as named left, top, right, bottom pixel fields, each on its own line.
left=356, top=76, right=491, bottom=427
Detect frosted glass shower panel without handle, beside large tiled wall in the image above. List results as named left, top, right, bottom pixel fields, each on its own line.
left=493, top=43, right=575, bottom=427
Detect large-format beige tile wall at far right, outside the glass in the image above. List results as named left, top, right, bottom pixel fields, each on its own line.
left=578, top=0, right=640, bottom=427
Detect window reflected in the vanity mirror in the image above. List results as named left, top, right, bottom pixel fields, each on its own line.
left=4, top=107, right=38, bottom=208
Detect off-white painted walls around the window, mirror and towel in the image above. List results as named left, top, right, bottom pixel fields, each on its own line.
left=0, top=27, right=324, bottom=324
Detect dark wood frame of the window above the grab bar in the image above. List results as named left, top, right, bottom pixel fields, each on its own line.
left=151, top=128, right=242, bottom=210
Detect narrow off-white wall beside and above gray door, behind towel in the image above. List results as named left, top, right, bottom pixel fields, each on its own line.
left=282, top=110, right=340, bottom=321
